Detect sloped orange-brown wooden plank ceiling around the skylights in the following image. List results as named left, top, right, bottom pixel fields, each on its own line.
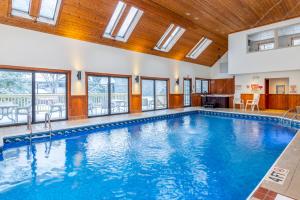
left=0, top=0, right=300, bottom=66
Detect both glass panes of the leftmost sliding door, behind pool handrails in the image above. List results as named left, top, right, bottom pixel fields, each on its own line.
left=0, top=70, right=67, bottom=126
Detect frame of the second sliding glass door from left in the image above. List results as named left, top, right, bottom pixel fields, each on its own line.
left=85, top=72, right=132, bottom=118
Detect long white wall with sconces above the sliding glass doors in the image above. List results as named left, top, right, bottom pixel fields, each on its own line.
left=0, top=25, right=210, bottom=95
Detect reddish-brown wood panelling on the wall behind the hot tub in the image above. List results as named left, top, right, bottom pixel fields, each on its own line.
left=210, top=78, right=234, bottom=94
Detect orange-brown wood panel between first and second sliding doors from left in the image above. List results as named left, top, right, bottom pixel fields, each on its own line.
left=69, top=95, right=88, bottom=120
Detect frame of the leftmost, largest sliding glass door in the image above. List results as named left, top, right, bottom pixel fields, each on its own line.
left=0, top=65, right=71, bottom=127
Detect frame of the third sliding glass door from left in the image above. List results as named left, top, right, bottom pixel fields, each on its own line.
left=140, top=76, right=170, bottom=112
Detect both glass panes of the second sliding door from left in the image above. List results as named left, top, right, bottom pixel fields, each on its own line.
left=88, top=75, right=129, bottom=116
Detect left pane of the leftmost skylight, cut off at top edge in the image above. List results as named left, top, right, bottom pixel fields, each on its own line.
left=11, top=0, right=31, bottom=18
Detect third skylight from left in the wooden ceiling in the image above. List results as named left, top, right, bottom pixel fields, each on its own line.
left=154, top=24, right=185, bottom=52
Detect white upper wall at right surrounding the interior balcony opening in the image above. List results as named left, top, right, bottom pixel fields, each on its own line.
left=228, top=18, right=300, bottom=75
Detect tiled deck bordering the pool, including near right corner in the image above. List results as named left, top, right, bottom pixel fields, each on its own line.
left=0, top=107, right=300, bottom=200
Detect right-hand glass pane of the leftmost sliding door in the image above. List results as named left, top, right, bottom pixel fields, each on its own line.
left=34, top=72, right=67, bottom=122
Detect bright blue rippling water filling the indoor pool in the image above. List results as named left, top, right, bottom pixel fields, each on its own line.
left=0, top=114, right=296, bottom=200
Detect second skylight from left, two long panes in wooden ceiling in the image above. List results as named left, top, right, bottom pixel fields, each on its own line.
left=103, top=1, right=144, bottom=42
